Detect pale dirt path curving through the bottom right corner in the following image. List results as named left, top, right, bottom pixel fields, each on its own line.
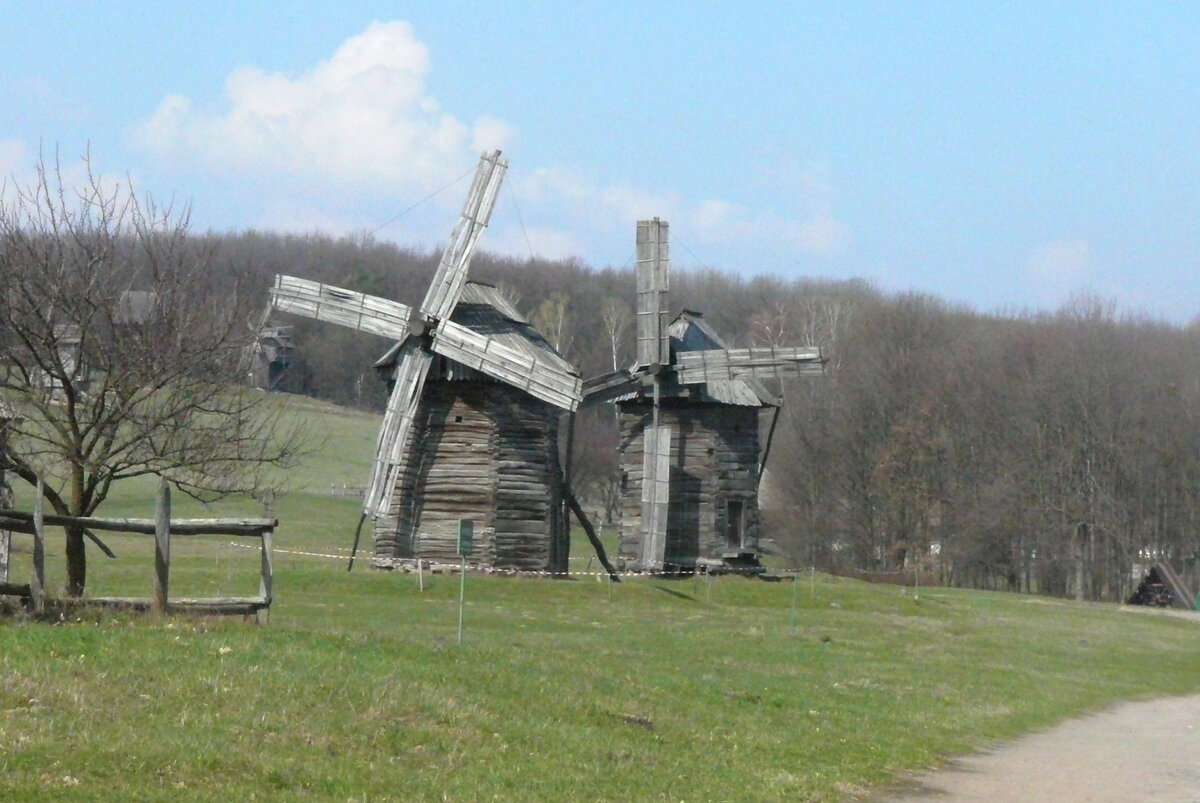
left=872, top=695, right=1200, bottom=803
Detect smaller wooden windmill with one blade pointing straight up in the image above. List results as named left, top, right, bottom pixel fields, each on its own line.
left=583, top=218, right=824, bottom=571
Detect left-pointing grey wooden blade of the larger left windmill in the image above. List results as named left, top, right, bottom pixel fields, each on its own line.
left=271, top=275, right=413, bottom=340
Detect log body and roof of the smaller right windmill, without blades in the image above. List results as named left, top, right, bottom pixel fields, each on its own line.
left=616, top=310, right=780, bottom=571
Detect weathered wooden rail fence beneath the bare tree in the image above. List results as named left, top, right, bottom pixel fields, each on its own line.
left=0, top=480, right=278, bottom=621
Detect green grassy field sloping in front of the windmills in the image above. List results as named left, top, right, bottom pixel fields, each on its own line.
left=0, top=391, right=1200, bottom=801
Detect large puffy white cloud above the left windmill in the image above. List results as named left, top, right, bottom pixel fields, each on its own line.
left=134, top=22, right=512, bottom=193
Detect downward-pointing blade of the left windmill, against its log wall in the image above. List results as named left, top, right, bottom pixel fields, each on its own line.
left=362, top=337, right=433, bottom=519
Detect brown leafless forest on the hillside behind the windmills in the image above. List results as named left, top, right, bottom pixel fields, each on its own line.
left=218, top=232, right=1200, bottom=600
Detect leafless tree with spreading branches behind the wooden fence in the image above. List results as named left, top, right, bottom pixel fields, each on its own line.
left=0, top=154, right=302, bottom=595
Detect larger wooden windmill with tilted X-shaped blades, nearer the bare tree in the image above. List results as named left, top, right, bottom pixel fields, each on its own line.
left=271, top=151, right=581, bottom=571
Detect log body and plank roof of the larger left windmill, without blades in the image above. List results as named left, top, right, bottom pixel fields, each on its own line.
left=374, top=282, right=574, bottom=573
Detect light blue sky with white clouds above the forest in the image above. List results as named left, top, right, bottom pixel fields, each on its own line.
left=0, top=0, right=1200, bottom=323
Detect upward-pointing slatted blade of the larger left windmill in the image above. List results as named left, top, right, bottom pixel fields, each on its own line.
left=421, top=150, right=509, bottom=320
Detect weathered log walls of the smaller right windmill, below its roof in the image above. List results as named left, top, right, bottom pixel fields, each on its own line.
left=618, top=398, right=760, bottom=568
